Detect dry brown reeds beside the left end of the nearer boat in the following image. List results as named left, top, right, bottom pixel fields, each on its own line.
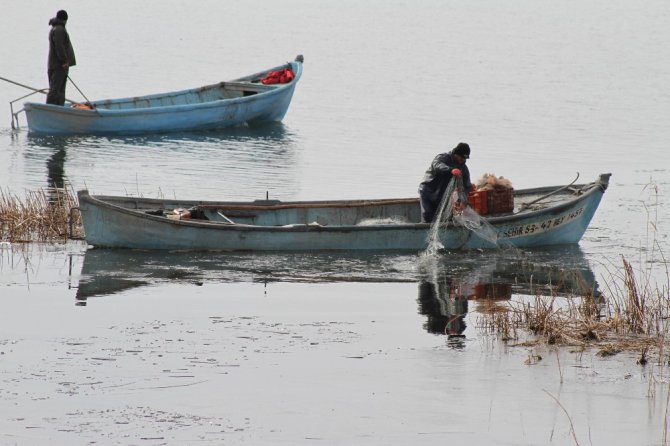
left=0, top=189, right=83, bottom=243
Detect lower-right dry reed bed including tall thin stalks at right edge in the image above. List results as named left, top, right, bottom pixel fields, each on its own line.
left=478, top=182, right=670, bottom=367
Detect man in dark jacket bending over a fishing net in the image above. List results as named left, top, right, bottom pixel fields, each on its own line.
left=419, top=142, right=472, bottom=223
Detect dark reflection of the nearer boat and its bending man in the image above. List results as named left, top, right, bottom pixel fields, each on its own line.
left=76, top=242, right=598, bottom=348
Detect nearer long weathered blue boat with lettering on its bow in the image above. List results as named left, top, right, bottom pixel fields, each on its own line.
left=77, top=173, right=611, bottom=251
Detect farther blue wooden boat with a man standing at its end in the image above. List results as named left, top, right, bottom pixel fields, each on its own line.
left=23, top=56, right=303, bottom=135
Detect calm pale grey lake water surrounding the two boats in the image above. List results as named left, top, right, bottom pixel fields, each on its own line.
left=0, top=0, right=670, bottom=444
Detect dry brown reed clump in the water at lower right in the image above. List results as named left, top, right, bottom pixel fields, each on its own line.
left=478, top=258, right=670, bottom=364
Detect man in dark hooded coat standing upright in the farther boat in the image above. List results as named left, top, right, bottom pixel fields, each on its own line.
left=47, top=10, right=77, bottom=105
